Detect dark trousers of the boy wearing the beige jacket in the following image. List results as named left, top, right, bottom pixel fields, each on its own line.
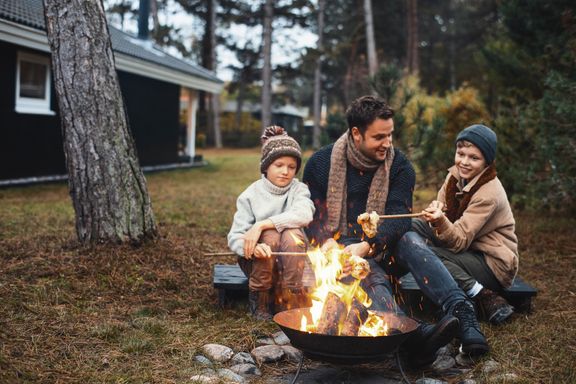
left=412, top=219, right=502, bottom=292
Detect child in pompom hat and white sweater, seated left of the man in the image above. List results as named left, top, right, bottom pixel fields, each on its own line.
left=228, top=126, right=314, bottom=320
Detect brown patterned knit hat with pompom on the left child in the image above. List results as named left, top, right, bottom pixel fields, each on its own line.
left=260, top=125, right=302, bottom=173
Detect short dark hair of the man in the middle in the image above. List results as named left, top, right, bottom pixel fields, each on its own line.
left=346, top=96, right=394, bottom=136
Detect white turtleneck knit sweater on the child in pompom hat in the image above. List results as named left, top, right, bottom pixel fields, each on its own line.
left=228, top=175, right=315, bottom=256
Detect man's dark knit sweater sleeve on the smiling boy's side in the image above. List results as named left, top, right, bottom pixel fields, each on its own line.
left=366, top=152, right=416, bottom=255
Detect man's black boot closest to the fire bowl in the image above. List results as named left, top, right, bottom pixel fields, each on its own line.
left=402, top=315, right=459, bottom=368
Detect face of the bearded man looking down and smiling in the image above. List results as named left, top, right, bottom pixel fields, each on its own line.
left=352, top=119, right=394, bottom=161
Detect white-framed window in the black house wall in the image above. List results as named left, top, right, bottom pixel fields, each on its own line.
left=16, top=52, right=55, bottom=115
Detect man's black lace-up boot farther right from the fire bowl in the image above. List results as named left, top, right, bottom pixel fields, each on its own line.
left=450, top=300, right=490, bottom=357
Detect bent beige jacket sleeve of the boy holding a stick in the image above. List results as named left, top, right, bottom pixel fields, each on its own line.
left=434, top=197, right=498, bottom=253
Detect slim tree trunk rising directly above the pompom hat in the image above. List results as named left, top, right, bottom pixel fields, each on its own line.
left=262, top=0, right=274, bottom=132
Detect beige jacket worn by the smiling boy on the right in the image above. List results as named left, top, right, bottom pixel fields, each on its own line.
left=434, top=166, right=518, bottom=288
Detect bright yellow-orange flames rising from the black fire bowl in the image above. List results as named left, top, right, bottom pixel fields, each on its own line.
left=300, top=240, right=388, bottom=336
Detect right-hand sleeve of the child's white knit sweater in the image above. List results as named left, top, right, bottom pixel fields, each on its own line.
left=270, top=182, right=314, bottom=232
